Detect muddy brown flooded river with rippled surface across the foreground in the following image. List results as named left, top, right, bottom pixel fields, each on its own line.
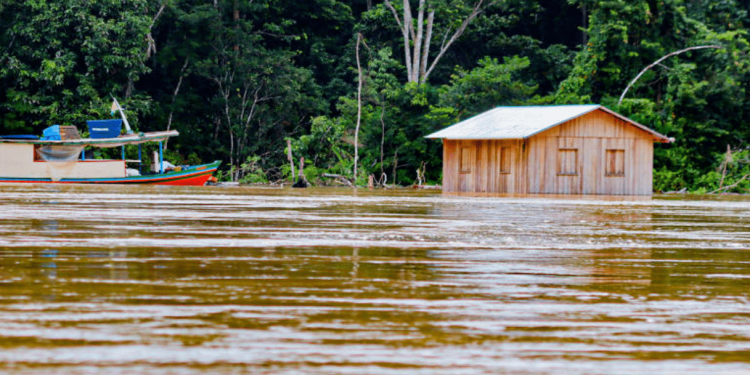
left=0, top=185, right=750, bottom=375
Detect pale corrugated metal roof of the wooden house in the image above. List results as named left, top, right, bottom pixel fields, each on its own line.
left=426, top=104, right=672, bottom=142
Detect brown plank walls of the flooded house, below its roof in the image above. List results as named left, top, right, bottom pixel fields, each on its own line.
left=443, top=110, right=654, bottom=195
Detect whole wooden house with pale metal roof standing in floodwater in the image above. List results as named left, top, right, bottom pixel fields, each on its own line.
left=427, top=105, right=674, bottom=195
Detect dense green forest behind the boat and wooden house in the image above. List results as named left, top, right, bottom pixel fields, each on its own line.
left=0, top=0, right=750, bottom=192
